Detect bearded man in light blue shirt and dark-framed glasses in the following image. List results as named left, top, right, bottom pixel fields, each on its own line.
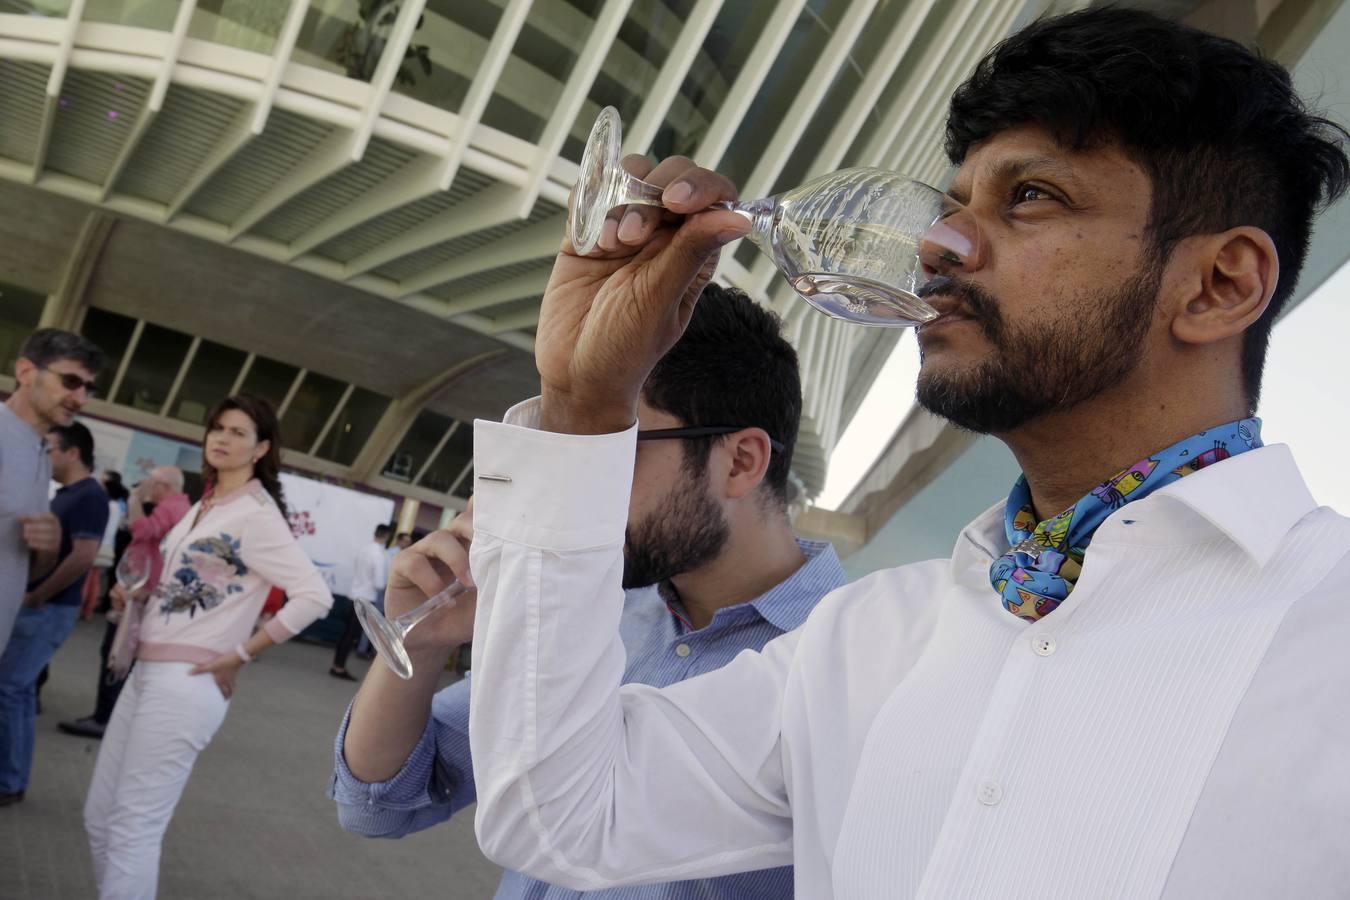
left=333, top=285, right=844, bottom=900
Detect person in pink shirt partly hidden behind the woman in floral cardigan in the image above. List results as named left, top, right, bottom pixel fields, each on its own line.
left=57, top=466, right=192, bottom=738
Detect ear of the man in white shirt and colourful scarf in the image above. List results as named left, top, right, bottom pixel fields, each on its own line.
left=1172, top=225, right=1280, bottom=344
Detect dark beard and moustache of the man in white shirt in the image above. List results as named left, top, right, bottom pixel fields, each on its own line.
left=917, top=263, right=1162, bottom=434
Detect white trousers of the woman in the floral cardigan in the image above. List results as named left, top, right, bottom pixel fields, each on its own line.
left=85, top=660, right=230, bottom=900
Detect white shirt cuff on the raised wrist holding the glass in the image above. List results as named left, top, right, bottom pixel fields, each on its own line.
left=474, top=398, right=637, bottom=552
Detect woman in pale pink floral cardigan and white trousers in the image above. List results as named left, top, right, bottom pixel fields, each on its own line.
left=85, top=395, right=332, bottom=900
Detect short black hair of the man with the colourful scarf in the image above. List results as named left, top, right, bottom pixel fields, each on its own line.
left=946, top=8, right=1350, bottom=412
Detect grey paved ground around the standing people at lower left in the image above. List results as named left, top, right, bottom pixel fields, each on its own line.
left=0, top=621, right=498, bottom=900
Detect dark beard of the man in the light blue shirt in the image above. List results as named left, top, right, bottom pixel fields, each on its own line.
left=624, top=472, right=730, bottom=591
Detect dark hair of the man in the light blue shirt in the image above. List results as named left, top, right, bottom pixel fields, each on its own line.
left=643, top=283, right=802, bottom=503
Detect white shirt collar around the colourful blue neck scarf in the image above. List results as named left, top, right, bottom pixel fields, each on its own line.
left=952, top=444, right=1318, bottom=575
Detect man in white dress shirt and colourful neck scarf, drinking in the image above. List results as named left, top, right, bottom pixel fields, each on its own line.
left=405, top=8, right=1350, bottom=900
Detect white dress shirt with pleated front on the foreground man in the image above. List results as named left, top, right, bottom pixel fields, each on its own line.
left=470, top=405, right=1350, bottom=900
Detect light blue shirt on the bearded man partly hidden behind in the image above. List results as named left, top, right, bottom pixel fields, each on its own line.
left=329, top=540, right=845, bottom=900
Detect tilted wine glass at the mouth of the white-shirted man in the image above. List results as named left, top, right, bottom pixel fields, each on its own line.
left=568, top=107, right=983, bottom=328
